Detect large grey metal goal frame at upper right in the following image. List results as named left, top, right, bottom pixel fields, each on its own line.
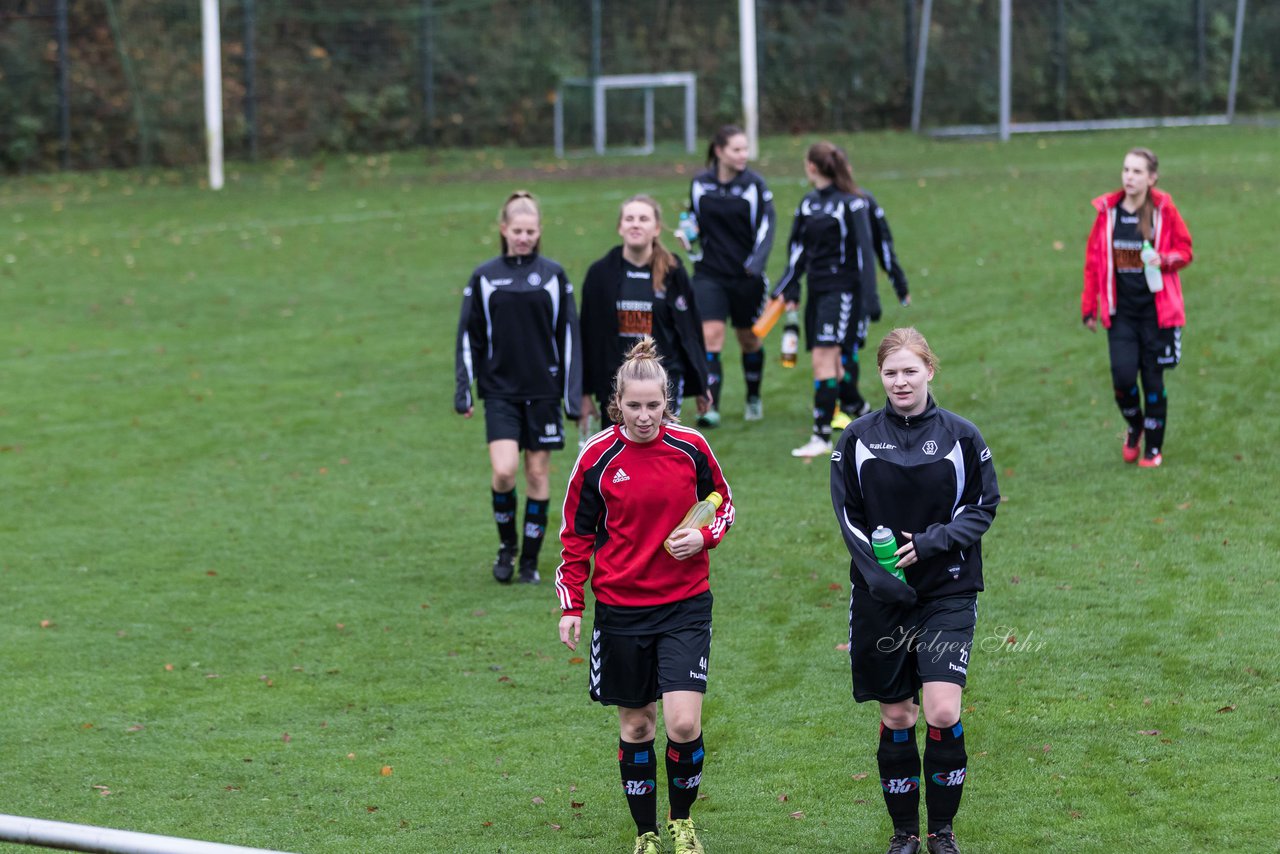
left=911, top=0, right=1247, bottom=142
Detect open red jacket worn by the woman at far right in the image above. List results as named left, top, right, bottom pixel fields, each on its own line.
left=1080, top=187, right=1192, bottom=329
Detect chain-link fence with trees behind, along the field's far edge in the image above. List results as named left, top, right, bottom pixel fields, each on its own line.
left=0, top=0, right=1280, bottom=172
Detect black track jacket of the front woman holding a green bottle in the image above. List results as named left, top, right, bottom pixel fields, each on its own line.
left=831, top=397, right=1000, bottom=606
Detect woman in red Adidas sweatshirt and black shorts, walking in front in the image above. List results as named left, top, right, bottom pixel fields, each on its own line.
left=556, top=338, right=733, bottom=854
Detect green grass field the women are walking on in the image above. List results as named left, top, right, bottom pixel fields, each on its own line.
left=0, top=128, right=1280, bottom=854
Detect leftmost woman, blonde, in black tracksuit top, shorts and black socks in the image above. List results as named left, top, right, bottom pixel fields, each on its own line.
left=453, top=192, right=582, bottom=584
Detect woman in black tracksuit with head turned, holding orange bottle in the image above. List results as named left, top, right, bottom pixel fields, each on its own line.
left=773, top=142, right=910, bottom=457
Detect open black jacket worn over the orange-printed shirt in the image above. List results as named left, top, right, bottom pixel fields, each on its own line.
left=582, top=246, right=707, bottom=401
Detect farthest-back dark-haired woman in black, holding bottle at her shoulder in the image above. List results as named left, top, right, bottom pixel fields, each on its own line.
left=677, top=124, right=777, bottom=428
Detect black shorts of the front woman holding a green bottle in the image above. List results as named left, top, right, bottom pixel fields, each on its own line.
left=849, top=588, right=978, bottom=703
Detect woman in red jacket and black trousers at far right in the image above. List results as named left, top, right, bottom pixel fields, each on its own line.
left=1080, top=149, right=1192, bottom=469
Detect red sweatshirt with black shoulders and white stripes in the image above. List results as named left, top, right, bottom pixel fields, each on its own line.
left=556, top=424, right=733, bottom=616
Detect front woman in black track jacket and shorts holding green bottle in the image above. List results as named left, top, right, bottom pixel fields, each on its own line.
left=831, top=328, right=1000, bottom=854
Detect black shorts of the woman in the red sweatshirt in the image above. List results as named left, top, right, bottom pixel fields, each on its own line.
left=588, top=594, right=712, bottom=708
